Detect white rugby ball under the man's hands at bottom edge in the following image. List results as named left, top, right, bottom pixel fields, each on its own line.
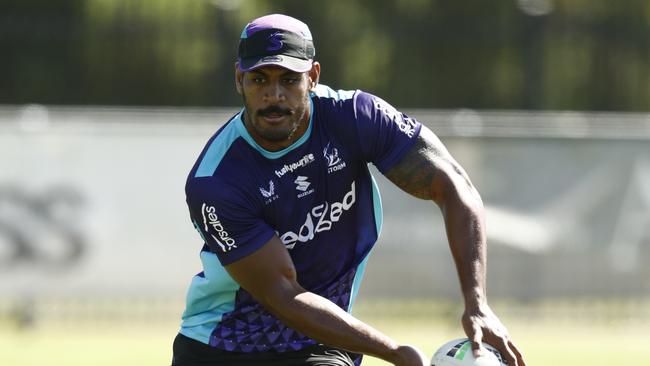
left=431, top=338, right=508, bottom=366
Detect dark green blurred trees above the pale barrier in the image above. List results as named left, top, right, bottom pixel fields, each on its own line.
left=0, top=0, right=650, bottom=111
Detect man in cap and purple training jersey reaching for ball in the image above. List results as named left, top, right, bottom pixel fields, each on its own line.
left=173, top=14, right=524, bottom=366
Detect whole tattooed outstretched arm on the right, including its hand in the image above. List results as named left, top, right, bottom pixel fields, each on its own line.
left=386, top=126, right=525, bottom=366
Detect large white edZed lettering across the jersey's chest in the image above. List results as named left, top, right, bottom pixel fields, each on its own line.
left=280, top=182, right=357, bottom=249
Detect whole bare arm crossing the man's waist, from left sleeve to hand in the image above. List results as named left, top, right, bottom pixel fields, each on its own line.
left=226, top=236, right=426, bottom=366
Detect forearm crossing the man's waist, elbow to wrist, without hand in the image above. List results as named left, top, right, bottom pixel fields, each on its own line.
left=265, top=290, right=399, bottom=363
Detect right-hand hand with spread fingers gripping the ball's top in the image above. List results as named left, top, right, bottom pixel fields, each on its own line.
left=462, top=303, right=526, bottom=366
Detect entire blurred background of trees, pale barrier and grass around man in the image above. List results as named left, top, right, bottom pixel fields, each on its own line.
left=0, top=0, right=650, bottom=366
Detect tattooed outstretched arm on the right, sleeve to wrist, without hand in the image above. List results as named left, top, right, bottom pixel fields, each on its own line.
left=386, top=127, right=486, bottom=306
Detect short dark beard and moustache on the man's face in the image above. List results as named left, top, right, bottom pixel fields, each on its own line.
left=242, top=95, right=309, bottom=143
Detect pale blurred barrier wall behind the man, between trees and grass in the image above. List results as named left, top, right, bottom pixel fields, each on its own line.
left=0, top=106, right=650, bottom=298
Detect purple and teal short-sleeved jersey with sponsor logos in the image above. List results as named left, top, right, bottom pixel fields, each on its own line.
left=180, top=85, right=421, bottom=352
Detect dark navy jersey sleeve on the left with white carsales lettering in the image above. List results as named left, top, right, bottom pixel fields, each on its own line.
left=186, top=177, right=275, bottom=266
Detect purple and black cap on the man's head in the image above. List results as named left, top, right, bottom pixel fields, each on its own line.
left=238, top=14, right=316, bottom=72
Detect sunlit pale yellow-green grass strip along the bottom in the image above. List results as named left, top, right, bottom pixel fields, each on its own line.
left=0, top=302, right=650, bottom=366
